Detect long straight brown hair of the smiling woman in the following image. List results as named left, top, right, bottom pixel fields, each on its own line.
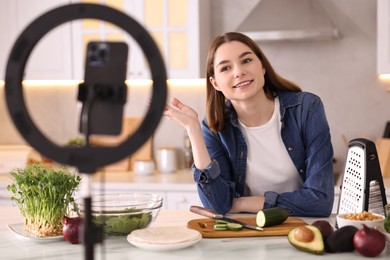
left=206, top=32, right=301, bottom=133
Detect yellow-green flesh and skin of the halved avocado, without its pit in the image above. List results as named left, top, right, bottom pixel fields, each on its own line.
left=287, top=225, right=325, bottom=255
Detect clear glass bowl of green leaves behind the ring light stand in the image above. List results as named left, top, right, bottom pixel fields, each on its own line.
left=77, top=193, right=163, bottom=236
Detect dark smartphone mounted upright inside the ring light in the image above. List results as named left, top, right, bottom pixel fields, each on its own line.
left=80, top=41, right=128, bottom=135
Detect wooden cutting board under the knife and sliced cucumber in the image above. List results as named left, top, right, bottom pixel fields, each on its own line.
left=187, top=217, right=307, bottom=238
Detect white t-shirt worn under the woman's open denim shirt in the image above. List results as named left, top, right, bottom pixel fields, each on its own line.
left=240, top=97, right=303, bottom=196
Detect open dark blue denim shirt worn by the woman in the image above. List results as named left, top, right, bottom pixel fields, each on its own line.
left=192, top=90, right=334, bottom=217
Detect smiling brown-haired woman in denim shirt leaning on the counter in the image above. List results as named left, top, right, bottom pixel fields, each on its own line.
left=164, top=32, right=334, bottom=216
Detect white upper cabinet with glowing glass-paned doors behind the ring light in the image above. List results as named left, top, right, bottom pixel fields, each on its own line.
left=72, top=0, right=209, bottom=79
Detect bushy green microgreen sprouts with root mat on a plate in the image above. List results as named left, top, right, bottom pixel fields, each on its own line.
left=7, top=164, right=81, bottom=236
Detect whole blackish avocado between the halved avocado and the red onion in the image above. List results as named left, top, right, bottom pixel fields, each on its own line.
left=325, top=226, right=358, bottom=253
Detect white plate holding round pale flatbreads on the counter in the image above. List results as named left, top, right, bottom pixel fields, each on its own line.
left=127, top=227, right=202, bottom=251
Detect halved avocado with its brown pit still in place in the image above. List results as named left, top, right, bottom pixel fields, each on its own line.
left=287, top=225, right=325, bottom=255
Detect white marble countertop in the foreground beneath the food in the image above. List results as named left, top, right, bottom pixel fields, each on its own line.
left=0, top=207, right=390, bottom=260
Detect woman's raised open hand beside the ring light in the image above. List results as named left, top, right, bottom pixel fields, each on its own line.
left=163, top=98, right=199, bottom=131
